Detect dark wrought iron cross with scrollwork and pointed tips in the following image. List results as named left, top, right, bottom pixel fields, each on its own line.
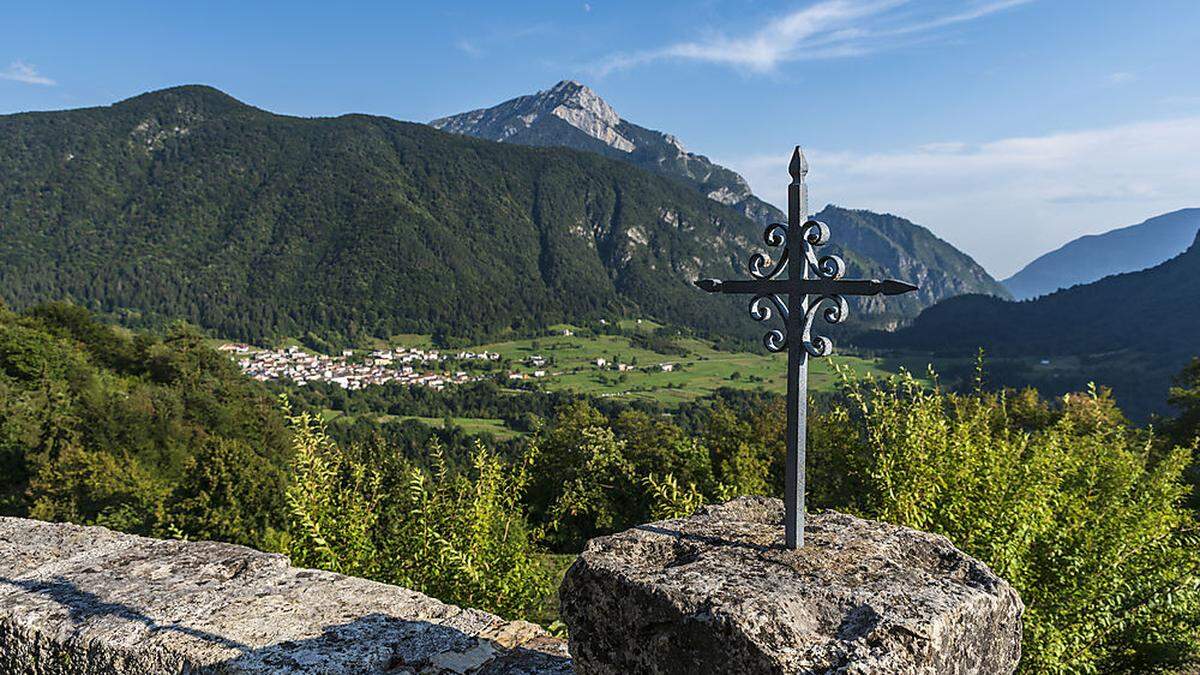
left=696, top=145, right=917, bottom=549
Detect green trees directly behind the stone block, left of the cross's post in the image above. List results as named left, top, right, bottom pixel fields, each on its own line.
left=528, top=401, right=781, bottom=551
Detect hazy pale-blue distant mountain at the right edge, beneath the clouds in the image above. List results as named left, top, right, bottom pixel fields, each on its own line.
left=1004, top=209, right=1200, bottom=300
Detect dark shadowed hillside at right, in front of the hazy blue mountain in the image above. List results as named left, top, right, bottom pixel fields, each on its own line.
left=862, top=229, right=1200, bottom=418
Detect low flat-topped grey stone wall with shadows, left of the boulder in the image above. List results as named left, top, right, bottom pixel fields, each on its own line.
left=0, top=518, right=570, bottom=675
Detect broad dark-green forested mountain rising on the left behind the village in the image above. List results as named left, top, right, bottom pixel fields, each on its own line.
left=0, top=86, right=761, bottom=341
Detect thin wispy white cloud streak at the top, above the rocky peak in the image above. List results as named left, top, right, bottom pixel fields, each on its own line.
left=588, top=0, right=1033, bottom=76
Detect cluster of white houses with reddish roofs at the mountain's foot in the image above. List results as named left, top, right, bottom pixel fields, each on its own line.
left=217, top=342, right=500, bottom=390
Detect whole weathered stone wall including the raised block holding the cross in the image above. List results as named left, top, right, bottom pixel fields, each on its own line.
left=0, top=497, right=1024, bottom=675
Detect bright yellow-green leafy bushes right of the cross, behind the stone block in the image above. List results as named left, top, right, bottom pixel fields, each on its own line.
left=810, top=375, right=1200, bottom=673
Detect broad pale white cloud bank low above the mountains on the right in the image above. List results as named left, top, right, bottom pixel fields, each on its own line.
left=724, top=117, right=1200, bottom=277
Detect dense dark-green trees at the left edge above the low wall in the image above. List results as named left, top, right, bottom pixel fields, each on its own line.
left=0, top=304, right=288, bottom=549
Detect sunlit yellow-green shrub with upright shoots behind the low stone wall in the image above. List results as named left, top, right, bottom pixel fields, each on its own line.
left=287, top=398, right=553, bottom=616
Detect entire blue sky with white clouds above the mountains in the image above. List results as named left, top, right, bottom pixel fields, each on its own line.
left=0, top=0, right=1200, bottom=276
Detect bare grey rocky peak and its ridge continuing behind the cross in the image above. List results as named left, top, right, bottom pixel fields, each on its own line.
left=430, top=80, right=1009, bottom=327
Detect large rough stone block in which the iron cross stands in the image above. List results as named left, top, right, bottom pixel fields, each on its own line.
left=559, top=497, right=1024, bottom=675
